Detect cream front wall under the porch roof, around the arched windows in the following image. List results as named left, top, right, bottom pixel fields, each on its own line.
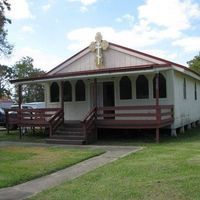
left=46, top=70, right=177, bottom=120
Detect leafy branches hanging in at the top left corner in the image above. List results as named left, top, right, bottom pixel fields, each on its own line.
left=0, top=0, right=13, bottom=56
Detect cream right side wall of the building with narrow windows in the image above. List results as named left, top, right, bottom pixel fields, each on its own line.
left=174, top=71, right=200, bottom=128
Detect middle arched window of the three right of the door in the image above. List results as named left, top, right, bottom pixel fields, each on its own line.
left=136, top=75, right=149, bottom=99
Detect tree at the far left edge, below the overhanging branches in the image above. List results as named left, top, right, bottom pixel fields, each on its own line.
left=0, top=65, right=12, bottom=98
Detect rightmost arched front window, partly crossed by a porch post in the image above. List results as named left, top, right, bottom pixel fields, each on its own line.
left=153, top=73, right=167, bottom=98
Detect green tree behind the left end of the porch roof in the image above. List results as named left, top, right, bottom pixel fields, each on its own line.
left=13, top=56, right=44, bottom=102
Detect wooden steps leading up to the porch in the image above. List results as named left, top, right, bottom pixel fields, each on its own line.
left=46, top=121, right=86, bottom=145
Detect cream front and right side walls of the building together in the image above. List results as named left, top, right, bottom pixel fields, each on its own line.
left=46, top=70, right=200, bottom=128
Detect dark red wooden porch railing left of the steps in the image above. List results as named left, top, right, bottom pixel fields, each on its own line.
left=6, top=108, right=64, bottom=136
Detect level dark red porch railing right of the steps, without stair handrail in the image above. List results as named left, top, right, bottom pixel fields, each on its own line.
left=97, top=105, right=173, bottom=128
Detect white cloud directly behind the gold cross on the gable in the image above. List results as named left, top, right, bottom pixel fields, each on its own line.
left=67, top=27, right=154, bottom=51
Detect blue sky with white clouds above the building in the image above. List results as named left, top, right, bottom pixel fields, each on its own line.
left=0, top=0, right=200, bottom=71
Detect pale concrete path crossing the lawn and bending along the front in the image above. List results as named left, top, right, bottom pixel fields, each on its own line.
left=0, top=142, right=142, bottom=200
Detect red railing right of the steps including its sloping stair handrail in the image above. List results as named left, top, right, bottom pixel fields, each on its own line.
left=82, top=105, right=174, bottom=138
